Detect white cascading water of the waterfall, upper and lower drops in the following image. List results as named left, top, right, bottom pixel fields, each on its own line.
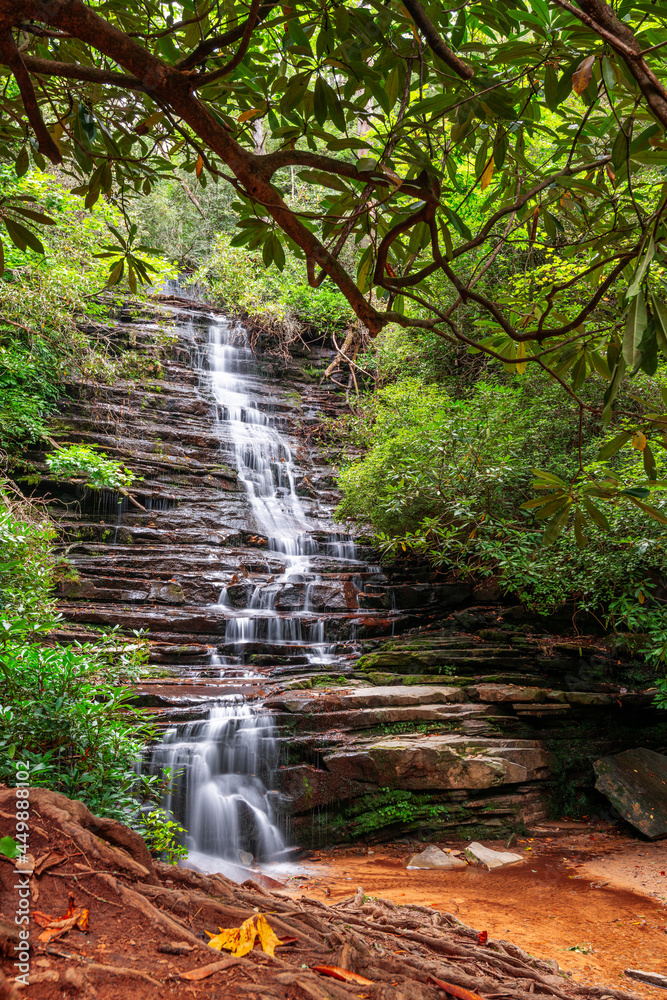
left=151, top=310, right=366, bottom=870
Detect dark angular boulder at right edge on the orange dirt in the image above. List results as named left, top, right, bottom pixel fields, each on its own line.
left=593, top=747, right=667, bottom=840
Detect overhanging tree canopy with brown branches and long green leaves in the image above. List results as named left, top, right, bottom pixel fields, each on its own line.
left=5, top=0, right=667, bottom=540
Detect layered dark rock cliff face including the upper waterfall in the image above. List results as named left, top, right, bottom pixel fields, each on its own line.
left=29, top=292, right=667, bottom=844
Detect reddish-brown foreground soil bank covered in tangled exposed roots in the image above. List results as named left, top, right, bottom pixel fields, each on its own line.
left=0, top=789, right=649, bottom=1000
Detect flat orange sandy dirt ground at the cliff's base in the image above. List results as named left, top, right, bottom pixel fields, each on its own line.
left=282, top=824, right=667, bottom=1000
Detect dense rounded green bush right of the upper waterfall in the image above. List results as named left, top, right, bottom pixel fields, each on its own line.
left=338, top=366, right=667, bottom=665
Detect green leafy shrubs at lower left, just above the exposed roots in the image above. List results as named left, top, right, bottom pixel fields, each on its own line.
left=0, top=484, right=152, bottom=821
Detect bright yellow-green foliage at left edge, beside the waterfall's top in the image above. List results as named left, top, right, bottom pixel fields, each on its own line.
left=0, top=167, right=174, bottom=456
